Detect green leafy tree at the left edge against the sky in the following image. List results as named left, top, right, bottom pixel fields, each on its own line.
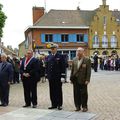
left=0, top=4, right=7, bottom=38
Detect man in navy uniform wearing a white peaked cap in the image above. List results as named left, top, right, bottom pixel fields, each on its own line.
left=46, top=44, right=65, bottom=110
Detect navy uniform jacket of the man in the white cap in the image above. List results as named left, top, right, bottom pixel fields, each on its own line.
left=46, top=53, right=66, bottom=80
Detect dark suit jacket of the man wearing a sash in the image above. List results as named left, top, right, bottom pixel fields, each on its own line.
left=20, top=57, right=40, bottom=82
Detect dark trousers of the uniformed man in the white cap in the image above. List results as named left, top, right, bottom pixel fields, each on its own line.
left=49, top=79, right=63, bottom=107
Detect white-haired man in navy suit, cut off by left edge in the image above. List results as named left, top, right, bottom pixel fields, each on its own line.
left=0, top=54, right=13, bottom=107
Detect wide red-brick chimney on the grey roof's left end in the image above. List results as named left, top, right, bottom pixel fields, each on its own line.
left=32, top=7, right=44, bottom=24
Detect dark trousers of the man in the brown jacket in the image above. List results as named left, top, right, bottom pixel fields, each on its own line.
left=73, top=82, right=88, bottom=108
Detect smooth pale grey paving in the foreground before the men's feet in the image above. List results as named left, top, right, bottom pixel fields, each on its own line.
left=0, top=108, right=95, bottom=120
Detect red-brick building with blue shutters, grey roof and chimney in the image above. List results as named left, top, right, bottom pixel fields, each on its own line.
left=25, top=7, right=89, bottom=60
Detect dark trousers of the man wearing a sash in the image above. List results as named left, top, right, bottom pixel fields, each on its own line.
left=22, top=78, right=37, bottom=105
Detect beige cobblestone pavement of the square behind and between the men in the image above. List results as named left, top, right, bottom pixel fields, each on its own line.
left=0, top=70, right=120, bottom=120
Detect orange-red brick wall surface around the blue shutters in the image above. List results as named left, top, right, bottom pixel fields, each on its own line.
left=33, top=29, right=89, bottom=55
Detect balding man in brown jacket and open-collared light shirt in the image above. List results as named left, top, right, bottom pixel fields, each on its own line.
left=70, top=47, right=91, bottom=112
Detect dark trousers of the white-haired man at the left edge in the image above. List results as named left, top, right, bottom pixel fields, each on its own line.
left=0, top=81, right=10, bottom=105
